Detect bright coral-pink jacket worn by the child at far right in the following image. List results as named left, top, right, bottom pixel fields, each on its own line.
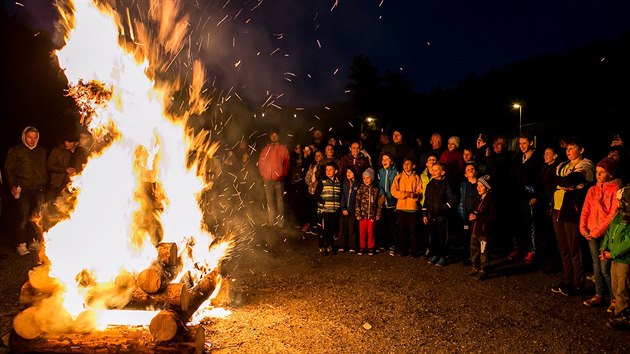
left=580, top=178, right=621, bottom=238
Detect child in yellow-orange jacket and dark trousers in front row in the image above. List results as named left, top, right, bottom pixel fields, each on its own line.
left=392, top=158, right=423, bottom=258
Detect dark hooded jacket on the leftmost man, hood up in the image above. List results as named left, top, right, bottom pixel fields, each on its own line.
left=4, top=126, right=48, bottom=189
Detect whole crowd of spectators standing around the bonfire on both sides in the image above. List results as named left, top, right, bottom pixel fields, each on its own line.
left=0, top=122, right=630, bottom=329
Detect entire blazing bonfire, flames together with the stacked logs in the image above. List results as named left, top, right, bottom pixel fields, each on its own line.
left=10, top=1, right=231, bottom=353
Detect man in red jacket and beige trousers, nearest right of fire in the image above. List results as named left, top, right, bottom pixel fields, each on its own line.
left=258, top=129, right=290, bottom=228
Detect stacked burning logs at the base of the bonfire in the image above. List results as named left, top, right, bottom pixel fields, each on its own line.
left=9, top=243, right=219, bottom=353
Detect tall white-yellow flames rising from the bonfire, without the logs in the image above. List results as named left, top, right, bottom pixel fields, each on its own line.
left=35, top=1, right=229, bottom=326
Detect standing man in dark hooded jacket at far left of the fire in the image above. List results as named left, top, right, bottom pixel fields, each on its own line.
left=4, top=126, right=48, bottom=256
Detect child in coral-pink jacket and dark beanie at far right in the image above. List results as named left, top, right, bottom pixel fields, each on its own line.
left=580, top=157, right=621, bottom=309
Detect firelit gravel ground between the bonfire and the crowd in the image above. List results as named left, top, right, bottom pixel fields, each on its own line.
left=0, top=228, right=630, bottom=353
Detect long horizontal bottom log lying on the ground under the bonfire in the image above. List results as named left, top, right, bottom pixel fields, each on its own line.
left=9, top=326, right=205, bottom=354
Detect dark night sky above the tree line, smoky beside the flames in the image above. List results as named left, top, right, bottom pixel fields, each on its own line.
left=11, top=0, right=630, bottom=107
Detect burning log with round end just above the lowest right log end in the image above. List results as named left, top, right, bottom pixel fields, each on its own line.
left=125, top=283, right=190, bottom=311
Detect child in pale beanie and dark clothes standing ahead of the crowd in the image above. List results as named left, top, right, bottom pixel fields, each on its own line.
left=468, top=175, right=496, bottom=280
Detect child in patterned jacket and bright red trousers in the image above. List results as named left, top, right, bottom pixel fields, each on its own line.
left=354, top=168, right=383, bottom=256
